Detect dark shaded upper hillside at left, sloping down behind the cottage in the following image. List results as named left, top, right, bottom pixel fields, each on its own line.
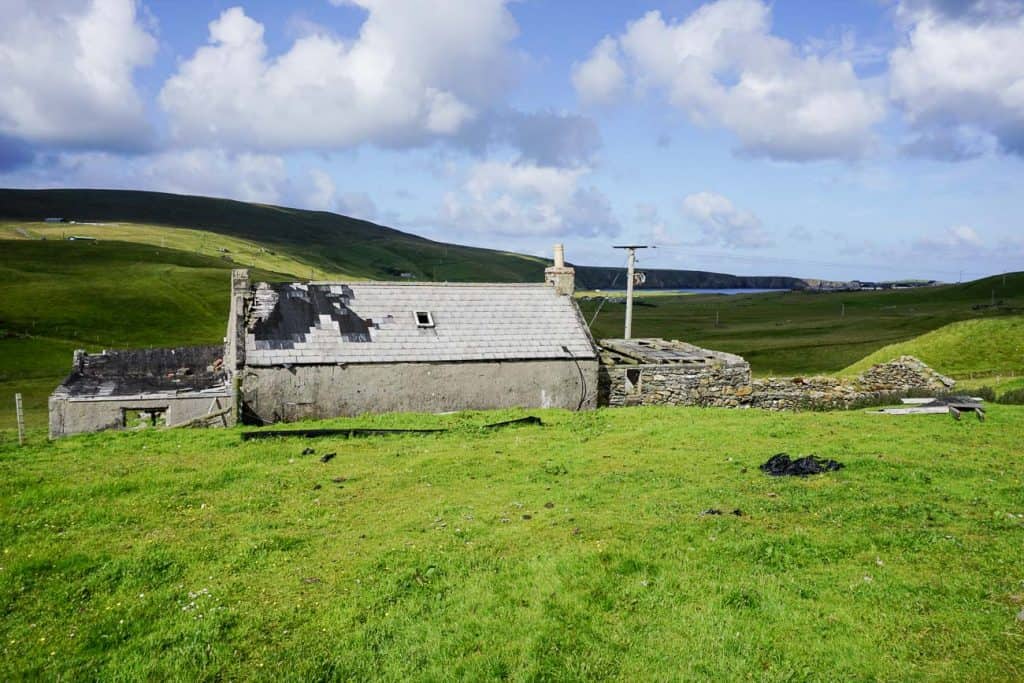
left=0, top=189, right=545, bottom=282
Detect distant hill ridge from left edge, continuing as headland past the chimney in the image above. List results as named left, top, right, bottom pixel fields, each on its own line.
left=0, top=189, right=804, bottom=288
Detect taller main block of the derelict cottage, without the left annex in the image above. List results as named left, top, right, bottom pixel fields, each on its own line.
left=226, top=264, right=597, bottom=422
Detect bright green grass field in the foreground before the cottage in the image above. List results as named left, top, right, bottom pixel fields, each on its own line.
left=0, top=405, right=1024, bottom=681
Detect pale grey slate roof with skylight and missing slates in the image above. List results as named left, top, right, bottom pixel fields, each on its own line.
left=246, top=283, right=596, bottom=367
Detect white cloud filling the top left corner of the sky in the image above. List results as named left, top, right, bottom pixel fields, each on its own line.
left=0, top=0, right=157, bottom=150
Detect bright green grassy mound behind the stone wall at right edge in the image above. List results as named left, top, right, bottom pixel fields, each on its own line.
left=844, top=315, right=1024, bottom=378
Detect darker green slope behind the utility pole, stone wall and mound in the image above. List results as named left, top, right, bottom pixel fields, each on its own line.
left=581, top=272, right=1024, bottom=375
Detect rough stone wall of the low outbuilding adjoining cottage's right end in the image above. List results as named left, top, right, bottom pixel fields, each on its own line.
left=598, top=351, right=752, bottom=408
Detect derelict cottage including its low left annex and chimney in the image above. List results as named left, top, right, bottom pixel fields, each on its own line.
left=50, top=249, right=598, bottom=437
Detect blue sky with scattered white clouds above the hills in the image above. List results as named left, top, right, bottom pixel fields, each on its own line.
left=0, top=0, right=1024, bottom=281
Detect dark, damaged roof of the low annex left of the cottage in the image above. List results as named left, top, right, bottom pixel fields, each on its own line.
left=54, top=346, right=227, bottom=398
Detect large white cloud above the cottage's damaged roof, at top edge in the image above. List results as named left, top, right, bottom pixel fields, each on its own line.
left=160, top=0, right=517, bottom=150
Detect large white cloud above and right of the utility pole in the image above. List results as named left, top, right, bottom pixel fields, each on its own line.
left=573, top=0, right=885, bottom=161
